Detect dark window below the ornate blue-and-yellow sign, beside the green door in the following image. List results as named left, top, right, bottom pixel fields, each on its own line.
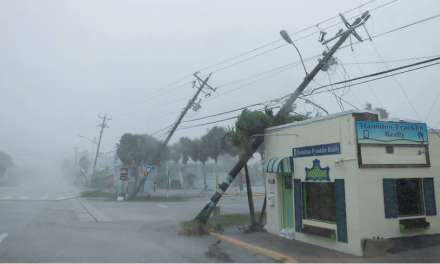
left=303, top=182, right=336, bottom=223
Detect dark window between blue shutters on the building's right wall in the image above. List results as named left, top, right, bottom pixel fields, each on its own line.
left=396, top=179, right=425, bottom=216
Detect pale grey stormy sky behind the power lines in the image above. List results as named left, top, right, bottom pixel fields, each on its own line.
left=0, top=0, right=440, bottom=168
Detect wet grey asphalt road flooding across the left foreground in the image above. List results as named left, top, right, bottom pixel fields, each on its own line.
left=0, top=183, right=274, bottom=262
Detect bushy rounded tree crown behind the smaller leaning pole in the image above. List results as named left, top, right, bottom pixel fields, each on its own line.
left=116, top=133, right=170, bottom=165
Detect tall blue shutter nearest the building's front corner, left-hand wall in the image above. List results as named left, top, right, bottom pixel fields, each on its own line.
left=335, top=179, right=348, bottom=243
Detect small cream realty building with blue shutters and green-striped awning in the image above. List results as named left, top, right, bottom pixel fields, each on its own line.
left=265, top=110, right=440, bottom=256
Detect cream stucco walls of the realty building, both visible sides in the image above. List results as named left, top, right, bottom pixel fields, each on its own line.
left=265, top=113, right=440, bottom=256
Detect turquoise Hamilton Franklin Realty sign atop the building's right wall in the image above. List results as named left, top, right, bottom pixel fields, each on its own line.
left=356, top=121, right=428, bottom=145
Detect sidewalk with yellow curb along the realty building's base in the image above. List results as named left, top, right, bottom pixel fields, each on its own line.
left=212, top=227, right=440, bottom=263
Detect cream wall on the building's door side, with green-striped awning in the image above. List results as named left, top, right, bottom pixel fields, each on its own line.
left=265, top=115, right=362, bottom=255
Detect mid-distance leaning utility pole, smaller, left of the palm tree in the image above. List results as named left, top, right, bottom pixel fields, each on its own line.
left=133, top=73, right=216, bottom=196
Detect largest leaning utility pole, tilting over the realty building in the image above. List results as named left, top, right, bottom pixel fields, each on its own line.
left=194, top=11, right=370, bottom=224
